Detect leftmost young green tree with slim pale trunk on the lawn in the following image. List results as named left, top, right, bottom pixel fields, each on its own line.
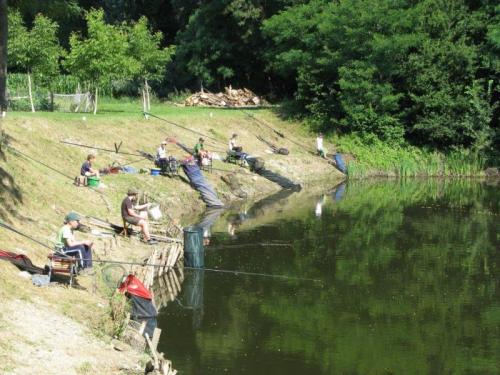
left=8, top=11, right=63, bottom=112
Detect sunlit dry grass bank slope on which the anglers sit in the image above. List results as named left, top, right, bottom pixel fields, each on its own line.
left=0, top=101, right=344, bottom=374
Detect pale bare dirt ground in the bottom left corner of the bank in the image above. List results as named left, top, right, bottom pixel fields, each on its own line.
left=0, top=299, right=141, bottom=375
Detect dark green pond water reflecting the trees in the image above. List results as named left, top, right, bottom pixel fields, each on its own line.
left=159, top=180, right=500, bottom=374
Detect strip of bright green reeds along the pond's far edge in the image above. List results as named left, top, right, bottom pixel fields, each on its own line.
left=333, top=135, right=485, bottom=178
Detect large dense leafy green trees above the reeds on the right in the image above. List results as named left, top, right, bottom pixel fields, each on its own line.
left=263, top=0, right=498, bottom=151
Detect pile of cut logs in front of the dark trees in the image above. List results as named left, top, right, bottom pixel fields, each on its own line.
left=184, top=86, right=265, bottom=107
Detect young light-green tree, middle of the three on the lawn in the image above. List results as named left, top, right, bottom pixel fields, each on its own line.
left=64, top=10, right=140, bottom=114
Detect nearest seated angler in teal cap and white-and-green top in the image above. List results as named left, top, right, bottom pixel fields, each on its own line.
left=56, top=212, right=93, bottom=269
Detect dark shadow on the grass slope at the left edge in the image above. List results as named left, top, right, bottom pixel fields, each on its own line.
left=0, top=132, right=23, bottom=221
